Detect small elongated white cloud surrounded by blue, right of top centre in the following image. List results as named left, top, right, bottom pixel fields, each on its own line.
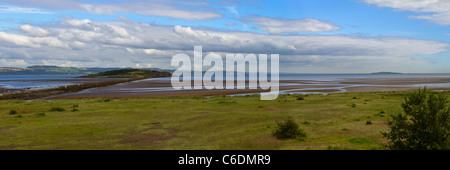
left=243, top=16, right=341, bottom=34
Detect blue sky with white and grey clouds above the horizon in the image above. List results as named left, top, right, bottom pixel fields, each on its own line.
left=0, top=0, right=450, bottom=73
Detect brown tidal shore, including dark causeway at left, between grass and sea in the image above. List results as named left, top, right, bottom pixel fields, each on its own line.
left=0, top=77, right=450, bottom=100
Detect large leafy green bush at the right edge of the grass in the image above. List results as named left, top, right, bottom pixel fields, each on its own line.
left=383, top=88, right=450, bottom=150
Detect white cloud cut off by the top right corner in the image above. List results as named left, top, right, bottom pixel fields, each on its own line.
left=364, top=0, right=450, bottom=25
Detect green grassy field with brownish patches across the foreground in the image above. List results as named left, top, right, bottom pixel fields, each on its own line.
left=0, top=92, right=442, bottom=150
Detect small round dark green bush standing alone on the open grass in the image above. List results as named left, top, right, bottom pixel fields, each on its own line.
left=273, top=117, right=306, bottom=140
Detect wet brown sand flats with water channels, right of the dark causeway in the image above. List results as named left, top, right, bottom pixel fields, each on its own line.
left=45, top=77, right=450, bottom=99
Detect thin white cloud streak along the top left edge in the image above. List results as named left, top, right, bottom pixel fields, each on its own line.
left=0, top=0, right=222, bottom=20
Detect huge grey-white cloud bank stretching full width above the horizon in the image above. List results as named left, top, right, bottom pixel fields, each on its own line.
left=0, top=18, right=450, bottom=72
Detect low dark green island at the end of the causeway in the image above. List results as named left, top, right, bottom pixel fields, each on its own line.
left=81, top=69, right=172, bottom=78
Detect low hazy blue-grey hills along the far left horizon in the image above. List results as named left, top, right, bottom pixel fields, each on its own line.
left=0, top=65, right=171, bottom=75
